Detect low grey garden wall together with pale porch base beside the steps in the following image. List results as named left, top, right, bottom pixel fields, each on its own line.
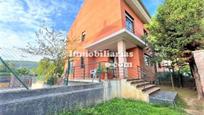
left=0, top=79, right=149, bottom=115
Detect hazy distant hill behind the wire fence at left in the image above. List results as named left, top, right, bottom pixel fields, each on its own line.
left=6, top=60, right=38, bottom=69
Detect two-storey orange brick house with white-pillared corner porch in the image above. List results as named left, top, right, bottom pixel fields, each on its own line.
left=65, top=0, right=155, bottom=81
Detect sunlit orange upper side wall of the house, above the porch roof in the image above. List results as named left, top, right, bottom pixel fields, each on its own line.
left=68, top=0, right=122, bottom=49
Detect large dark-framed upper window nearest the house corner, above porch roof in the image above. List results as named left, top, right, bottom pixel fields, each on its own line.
left=125, top=12, right=134, bottom=33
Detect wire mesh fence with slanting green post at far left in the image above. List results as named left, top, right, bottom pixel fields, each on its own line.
left=0, top=47, right=41, bottom=89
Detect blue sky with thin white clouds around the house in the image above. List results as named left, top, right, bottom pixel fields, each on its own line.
left=0, top=0, right=163, bottom=61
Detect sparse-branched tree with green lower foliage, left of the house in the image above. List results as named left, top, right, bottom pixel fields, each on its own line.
left=21, top=27, right=66, bottom=80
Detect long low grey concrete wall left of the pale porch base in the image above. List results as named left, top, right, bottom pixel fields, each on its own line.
left=0, top=83, right=104, bottom=115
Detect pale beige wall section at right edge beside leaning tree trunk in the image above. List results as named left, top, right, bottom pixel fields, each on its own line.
left=193, top=50, right=204, bottom=92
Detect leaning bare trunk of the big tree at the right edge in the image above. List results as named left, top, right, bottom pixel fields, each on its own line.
left=189, top=60, right=204, bottom=99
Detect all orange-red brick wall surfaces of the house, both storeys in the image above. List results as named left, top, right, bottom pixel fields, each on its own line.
left=65, top=0, right=148, bottom=77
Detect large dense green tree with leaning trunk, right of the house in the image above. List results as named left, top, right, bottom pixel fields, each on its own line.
left=147, top=0, right=204, bottom=98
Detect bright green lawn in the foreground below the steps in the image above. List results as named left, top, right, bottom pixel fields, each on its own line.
left=59, top=99, right=185, bottom=115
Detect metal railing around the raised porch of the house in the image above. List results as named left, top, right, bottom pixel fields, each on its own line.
left=69, top=62, right=155, bottom=81
